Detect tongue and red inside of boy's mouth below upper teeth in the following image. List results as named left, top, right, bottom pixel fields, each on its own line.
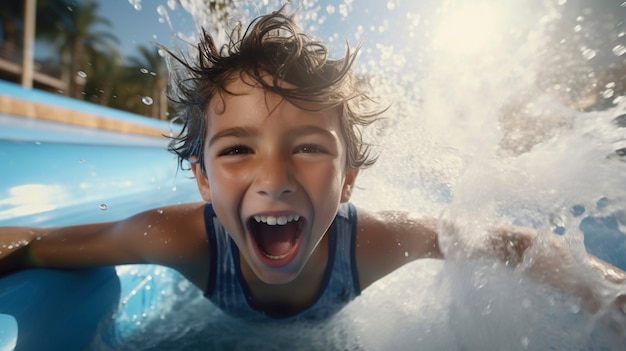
left=254, top=222, right=298, bottom=256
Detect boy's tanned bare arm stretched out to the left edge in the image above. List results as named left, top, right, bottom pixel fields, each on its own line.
left=0, top=203, right=208, bottom=284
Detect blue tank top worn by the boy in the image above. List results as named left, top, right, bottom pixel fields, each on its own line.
left=204, top=203, right=361, bottom=321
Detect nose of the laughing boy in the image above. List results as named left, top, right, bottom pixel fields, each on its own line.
left=254, top=157, right=296, bottom=198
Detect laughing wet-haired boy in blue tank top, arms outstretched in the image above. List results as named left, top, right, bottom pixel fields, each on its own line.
left=0, top=8, right=626, bottom=319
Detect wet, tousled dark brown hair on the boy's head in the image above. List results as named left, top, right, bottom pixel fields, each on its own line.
left=168, top=9, right=384, bottom=173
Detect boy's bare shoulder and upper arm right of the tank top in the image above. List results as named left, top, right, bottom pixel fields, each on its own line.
left=356, top=208, right=442, bottom=289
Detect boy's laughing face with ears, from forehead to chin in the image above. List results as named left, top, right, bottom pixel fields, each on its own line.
left=194, top=75, right=358, bottom=284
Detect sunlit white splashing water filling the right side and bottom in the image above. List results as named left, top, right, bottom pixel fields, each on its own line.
left=91, top=0, right=626, bottom=350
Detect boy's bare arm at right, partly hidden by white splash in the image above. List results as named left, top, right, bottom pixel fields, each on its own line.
left=356, top=210, right=626, bottom=322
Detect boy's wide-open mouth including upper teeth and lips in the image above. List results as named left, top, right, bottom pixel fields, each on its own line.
left=248, top=215, right=304, bottom=264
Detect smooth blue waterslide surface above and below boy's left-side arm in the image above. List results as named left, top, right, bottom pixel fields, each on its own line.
left=0, top=81, right=200, bottom=350
